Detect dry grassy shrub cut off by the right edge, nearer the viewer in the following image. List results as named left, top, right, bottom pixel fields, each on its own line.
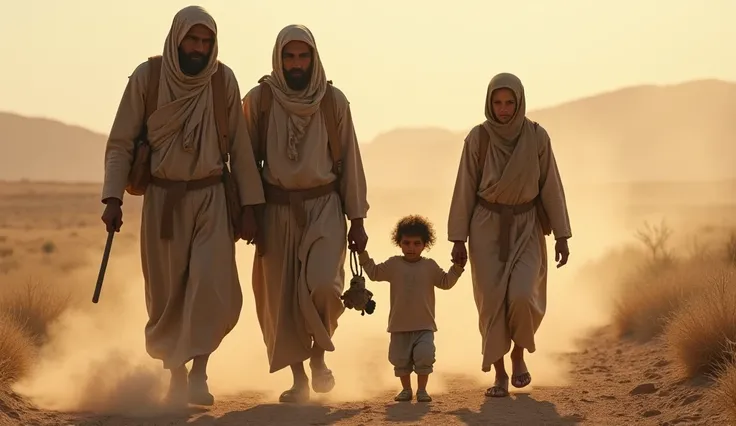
left=665, top=266, right=736, bottom=377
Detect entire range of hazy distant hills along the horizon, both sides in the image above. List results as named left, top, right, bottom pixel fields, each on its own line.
left=0, top=80, right=736, bottom=187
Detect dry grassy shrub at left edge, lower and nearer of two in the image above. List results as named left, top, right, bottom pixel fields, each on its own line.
left=0, top=314, right=36, bottom=388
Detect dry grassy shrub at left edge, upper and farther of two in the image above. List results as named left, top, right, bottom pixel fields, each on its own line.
left=0, top=280, right=71, bottom=346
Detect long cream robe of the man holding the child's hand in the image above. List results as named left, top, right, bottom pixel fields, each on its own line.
left=243, top=82, right=369, bottom=372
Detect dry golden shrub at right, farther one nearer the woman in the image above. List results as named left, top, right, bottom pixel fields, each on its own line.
left=613, top=260, right=707, bottom=341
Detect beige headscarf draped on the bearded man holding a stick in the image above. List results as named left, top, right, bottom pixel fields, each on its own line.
left=148, top=6, right=218, bottom=152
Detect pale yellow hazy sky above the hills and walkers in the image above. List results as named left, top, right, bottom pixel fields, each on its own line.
left=0, top=0, right=736, bottom=141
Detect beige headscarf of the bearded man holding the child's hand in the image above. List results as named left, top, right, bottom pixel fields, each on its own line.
left=265, top=25, right=327, bottom=161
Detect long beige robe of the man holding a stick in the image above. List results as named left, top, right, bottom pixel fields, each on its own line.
left=102, top=8, right=264, bottom=368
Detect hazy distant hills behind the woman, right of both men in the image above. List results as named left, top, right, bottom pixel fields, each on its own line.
left=362, top=80, right=736, bottom=186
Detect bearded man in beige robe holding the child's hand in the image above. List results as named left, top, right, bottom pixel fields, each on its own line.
left=243, top=25, right=369, bottom=402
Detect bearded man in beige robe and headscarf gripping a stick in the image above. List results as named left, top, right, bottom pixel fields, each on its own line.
left=102, top=6, right=265, bottom=405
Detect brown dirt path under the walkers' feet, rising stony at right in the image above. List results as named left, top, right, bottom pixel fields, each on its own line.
left=4, top=329, right=726, bottom=426
